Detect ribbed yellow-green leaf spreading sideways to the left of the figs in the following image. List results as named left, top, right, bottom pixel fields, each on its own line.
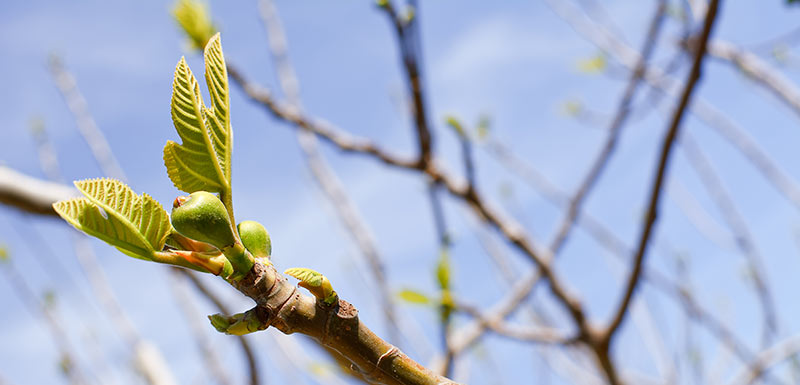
left=53, top=178, right=172, bottom=260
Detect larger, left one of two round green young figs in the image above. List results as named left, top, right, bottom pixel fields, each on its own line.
left=170, top=191, right=236, bottom=250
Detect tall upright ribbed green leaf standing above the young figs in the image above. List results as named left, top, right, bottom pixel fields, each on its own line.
left=164, top=34, right=233, bottom=195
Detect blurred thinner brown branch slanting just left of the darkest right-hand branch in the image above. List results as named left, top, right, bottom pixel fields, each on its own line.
left=550, top=0, right=667, bottom=255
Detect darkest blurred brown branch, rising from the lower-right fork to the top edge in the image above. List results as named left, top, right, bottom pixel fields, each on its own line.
left=604, top=0, right=720, bottom=345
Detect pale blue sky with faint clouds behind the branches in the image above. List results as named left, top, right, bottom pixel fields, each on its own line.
left=0, top=0, right=800, bottom=384
